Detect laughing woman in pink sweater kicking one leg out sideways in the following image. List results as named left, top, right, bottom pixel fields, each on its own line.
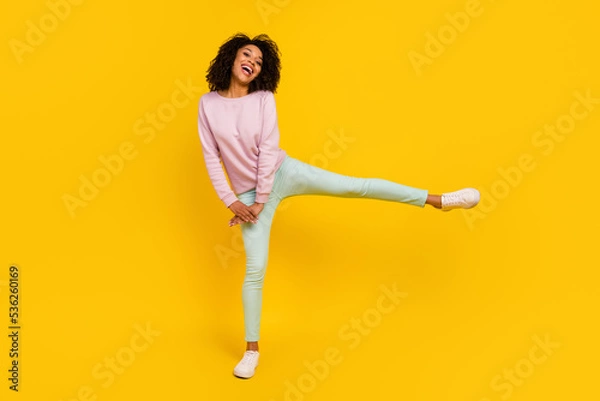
left=198, top=33, right=479, bottom=378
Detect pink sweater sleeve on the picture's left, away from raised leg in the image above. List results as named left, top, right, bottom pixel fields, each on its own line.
left=198, top=99, right=237, bottom=207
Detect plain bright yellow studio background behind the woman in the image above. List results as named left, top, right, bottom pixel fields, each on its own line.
left=0, top=0, right=600, bottom=401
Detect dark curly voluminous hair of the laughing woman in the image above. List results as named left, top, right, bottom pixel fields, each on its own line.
left=206, top=33, right=281, bottom=93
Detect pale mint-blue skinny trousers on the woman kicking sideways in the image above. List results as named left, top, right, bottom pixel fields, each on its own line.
left=238, top=156, right=428, bottom=341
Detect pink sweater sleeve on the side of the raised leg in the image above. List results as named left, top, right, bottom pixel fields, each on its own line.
left=256, top=92, right=280, bottom=203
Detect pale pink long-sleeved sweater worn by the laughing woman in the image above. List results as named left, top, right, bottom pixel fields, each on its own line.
left=198, top=91, right=286, bottom=207
